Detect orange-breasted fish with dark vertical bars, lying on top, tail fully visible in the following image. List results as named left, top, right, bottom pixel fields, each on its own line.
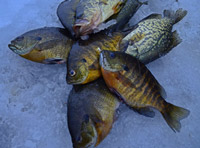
left=99, top=50, right=190, bottom=132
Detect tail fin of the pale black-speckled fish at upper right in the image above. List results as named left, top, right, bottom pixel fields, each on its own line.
left=163, top=8, right=187, bottom=24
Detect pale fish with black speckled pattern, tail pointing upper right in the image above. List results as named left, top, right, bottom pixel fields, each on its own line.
left=120, top=8, right=187, bottom=64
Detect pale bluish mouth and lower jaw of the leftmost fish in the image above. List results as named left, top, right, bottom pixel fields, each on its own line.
left=8, top=43, right=35, bottom=55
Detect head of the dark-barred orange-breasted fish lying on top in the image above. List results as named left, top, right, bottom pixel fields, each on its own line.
left=99, top=50, right=127, bottom=72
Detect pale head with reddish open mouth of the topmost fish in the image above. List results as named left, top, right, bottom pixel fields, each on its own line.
left=73, top=2, right=101, bottom=37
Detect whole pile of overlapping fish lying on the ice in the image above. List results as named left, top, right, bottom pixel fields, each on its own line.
left=8, top=0, right=189, bottom=148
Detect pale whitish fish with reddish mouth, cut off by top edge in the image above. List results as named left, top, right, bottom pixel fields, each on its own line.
left=73, top=0, right=126, bottom=37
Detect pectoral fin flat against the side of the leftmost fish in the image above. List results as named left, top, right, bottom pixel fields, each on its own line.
left=36, top=39, right=60, bottom=51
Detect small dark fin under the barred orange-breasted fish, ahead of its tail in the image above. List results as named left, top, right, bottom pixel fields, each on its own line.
left=133, top=107, right=155, bottom=118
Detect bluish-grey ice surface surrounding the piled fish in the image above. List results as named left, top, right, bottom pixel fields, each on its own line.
left=0, top=0, right=200, bottom=148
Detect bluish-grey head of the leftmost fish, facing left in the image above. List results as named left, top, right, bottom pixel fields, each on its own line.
left=8, top=35, right=42, bottom=55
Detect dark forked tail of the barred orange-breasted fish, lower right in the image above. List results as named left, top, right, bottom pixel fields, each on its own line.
left=162, top=103, right=190, bottom=132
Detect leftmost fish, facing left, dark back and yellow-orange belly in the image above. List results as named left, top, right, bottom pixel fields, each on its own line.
left=8, top=27, right=73, bottom=64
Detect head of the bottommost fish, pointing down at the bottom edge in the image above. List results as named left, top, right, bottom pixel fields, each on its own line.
left=72, top=114, right=97, bottom=148
